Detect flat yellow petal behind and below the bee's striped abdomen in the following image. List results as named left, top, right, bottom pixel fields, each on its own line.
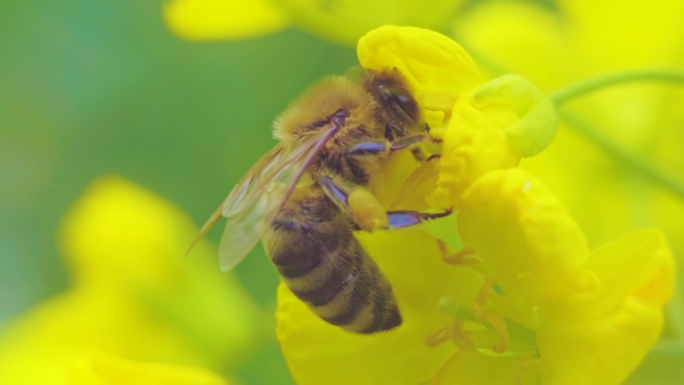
left=277, top=229, right=482, bottom=385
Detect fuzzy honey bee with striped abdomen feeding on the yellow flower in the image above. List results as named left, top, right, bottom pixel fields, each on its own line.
left=193, top=69, right=450, bottom=333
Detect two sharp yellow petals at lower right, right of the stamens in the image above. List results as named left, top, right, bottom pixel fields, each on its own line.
left=458, top=169, right=674, bottom=384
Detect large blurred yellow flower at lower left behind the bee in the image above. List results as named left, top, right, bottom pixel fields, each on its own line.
left=0, top=176, right=262, bottom=384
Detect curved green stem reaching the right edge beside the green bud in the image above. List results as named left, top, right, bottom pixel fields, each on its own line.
left=549, top=71, right=684, bottom=107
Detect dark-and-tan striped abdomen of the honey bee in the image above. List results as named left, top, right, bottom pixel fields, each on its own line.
left=264, top=186, right=401, bottom=333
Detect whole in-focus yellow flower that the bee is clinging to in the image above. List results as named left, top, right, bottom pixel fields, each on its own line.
left=277, top=27, right=674, bottom=385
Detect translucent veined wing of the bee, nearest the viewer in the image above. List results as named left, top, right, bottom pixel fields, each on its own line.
left=215, top=128, right=337, bottom=271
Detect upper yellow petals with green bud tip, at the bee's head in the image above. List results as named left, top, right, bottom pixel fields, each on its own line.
left=357, top=26, right=556, bottom=208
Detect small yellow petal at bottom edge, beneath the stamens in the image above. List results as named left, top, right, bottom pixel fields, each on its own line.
left=430, top=351, right=539, bottom=385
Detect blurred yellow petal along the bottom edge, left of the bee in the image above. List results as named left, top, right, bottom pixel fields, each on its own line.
left=67, top=354, right=227, bottom=385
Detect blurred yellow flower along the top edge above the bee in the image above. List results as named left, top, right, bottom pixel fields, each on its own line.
left=164, top=0, right=464, bottom=46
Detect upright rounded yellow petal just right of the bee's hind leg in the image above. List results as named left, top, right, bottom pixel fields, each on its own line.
left=458, top=169, right=597, bottom=305
